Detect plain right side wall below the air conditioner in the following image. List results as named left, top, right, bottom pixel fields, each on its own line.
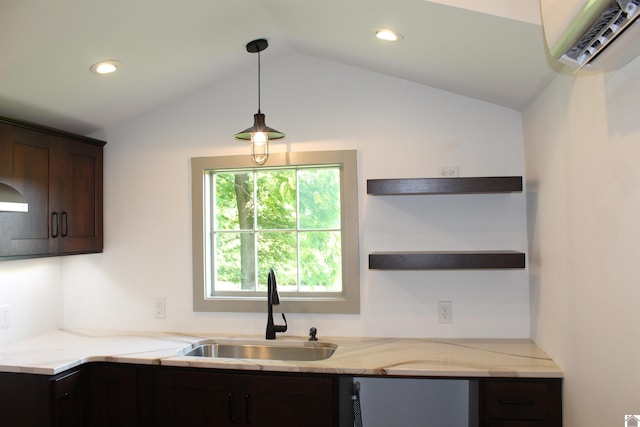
left=524, top=58, right=640, bottom=427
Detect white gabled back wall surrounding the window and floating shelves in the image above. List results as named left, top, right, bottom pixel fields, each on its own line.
left=58, top=55, right=530, bottom=337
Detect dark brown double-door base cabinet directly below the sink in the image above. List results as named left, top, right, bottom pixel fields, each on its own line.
left=157, top=369, right=338, bottom=427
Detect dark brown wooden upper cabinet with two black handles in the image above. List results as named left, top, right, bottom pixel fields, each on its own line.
left=0, top=117, right=106, bottom=260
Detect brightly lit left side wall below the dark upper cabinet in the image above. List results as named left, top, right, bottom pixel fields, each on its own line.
left=0, top=258, right=63, bottom=351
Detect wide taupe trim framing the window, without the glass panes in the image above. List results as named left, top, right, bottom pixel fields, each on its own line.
left=191, top=150, right=360, bottom=314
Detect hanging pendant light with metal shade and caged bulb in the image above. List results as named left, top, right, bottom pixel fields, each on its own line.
left=236, top=39, right=284, bottom=165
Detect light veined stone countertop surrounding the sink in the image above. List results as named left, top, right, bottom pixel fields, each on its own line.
left=0, top=330, right=563, bottom=378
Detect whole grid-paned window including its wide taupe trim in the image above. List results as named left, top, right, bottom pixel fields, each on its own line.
left=191, top=151, right=360, bottom=313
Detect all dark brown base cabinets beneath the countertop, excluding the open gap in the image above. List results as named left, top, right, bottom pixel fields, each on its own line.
left=0, top=363, right=562, bottom=427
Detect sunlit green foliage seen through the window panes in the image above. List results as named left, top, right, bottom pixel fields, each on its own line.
left=212, top=167, right=342, bottom=292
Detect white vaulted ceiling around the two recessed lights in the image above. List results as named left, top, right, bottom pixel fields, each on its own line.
left=0, top=0, right=553, bottom=134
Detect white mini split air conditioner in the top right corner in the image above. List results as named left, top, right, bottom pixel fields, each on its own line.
left=540, top=0, right=640, bottom=71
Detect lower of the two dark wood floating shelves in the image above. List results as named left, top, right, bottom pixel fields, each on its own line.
left=369, top=251, right=525, bottom=270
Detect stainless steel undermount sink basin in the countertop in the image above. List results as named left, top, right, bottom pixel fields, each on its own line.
left=181, top=340, right=338, bottom=361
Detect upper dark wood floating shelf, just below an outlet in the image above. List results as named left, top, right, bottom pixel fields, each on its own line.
left=367, top=176, right=522, bottom=196
